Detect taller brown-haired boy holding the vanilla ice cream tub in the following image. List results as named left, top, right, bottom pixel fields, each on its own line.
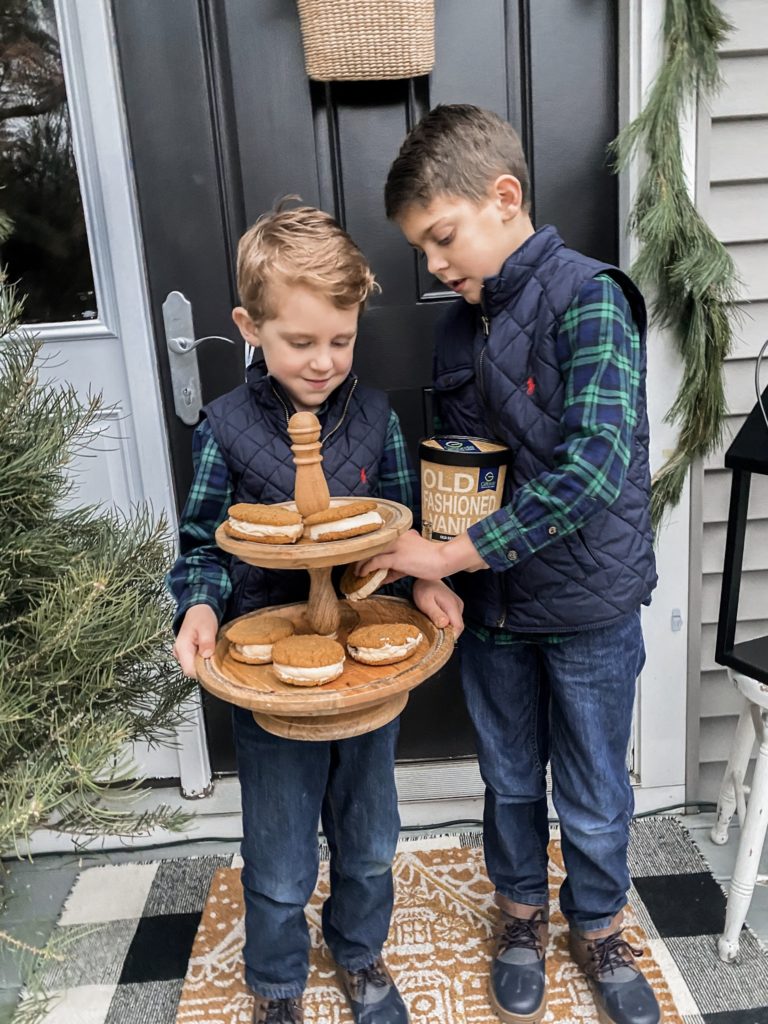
left=361, top=105, right=658, bottom=1024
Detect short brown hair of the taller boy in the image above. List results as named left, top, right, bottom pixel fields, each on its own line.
left=384, top=103, right=530, bottom=219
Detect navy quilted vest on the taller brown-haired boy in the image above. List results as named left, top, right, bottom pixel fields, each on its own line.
left=434, top=227, right=656, bottom=633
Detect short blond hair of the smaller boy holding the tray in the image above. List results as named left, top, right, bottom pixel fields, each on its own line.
left=238, top=206, right=378, bottom=326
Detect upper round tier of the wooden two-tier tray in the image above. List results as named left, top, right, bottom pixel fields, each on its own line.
left=216, top=498, right=414, bottom=569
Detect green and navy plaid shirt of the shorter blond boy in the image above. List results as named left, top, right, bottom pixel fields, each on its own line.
left=166, top=410, right=416, bottom=632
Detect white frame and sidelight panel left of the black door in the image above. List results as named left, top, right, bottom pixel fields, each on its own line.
left=55, top=0, right=211, bottom=797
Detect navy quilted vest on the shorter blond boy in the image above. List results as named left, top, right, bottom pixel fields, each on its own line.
left=203, top=361, right=389, bottom=621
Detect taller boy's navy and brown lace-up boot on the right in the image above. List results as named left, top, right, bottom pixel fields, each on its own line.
left=569, top=929, right=662, bottom=1024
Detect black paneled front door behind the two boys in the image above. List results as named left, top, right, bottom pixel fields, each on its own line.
left=113, top=0, right=618, bottom=771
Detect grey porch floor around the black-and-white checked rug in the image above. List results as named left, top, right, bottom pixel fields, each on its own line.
left=0, top=813, right=768, bottom=1024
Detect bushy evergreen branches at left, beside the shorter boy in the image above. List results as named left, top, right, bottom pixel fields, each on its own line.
left=0, top=329, right=195, bottom=853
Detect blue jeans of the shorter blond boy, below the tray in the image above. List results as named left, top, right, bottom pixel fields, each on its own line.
left=232, top=708, right=400, bottom=999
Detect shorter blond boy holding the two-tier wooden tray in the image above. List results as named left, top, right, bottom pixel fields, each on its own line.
left=170, top=207, right=462, bottom=1024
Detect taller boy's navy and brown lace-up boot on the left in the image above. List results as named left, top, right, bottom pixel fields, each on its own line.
left=490, top=907, right=549, bottom=1024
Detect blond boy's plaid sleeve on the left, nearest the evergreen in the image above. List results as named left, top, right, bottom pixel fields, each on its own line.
left=166, top=420, right=232, bottom=632
